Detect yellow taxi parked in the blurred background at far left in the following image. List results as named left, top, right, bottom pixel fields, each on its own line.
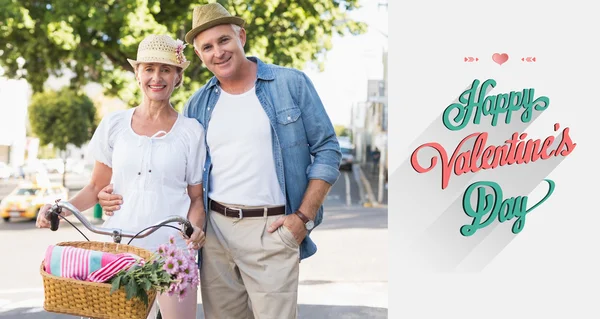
left=0, top=183, right=69, bottom=222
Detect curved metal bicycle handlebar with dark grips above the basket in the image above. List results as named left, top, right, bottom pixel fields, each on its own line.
left=46, top=200, right=194, bottom=243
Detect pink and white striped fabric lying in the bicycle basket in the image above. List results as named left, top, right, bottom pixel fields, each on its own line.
left=44, top=245, right=139, bottom=282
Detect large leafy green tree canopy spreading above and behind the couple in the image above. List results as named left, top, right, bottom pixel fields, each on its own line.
left=0, top=0, right=366, bottom=109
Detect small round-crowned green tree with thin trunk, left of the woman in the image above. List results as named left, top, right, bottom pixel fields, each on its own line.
left=28, top=87, right=97, bottom=186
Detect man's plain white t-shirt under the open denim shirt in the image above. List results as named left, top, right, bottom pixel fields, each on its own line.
left=206, top=88, right=285, bottom=206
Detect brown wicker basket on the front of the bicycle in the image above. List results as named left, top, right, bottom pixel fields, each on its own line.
left=40, top=241, right=156, bottom=319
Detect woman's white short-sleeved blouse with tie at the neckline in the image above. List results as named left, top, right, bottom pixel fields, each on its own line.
left=88, top=108, right=206, bottom=251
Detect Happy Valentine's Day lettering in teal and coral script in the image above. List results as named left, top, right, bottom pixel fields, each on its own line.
left=411, top=79, right=577, bottom=236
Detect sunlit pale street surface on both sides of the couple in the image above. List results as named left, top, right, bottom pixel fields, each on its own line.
left=0, top=169, right=388, bottom=319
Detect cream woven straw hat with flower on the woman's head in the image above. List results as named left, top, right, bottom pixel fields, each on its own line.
left=127, top=34, right=190, bottom=70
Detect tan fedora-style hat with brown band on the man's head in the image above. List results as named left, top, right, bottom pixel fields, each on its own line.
left=185, top=3, right=245, bottom=44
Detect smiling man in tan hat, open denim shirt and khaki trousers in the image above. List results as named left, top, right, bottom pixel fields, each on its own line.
left=100, top=3, right=341, bottom=319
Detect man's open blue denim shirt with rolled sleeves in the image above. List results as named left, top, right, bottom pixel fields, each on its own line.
left=184, top=57, right=342, bottom=259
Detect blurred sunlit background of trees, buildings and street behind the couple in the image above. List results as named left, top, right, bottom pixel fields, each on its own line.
left=0, top=0, right=388, bottom=318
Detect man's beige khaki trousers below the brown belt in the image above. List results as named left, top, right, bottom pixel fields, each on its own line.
left=200, top=205, right=300, bottom=319
